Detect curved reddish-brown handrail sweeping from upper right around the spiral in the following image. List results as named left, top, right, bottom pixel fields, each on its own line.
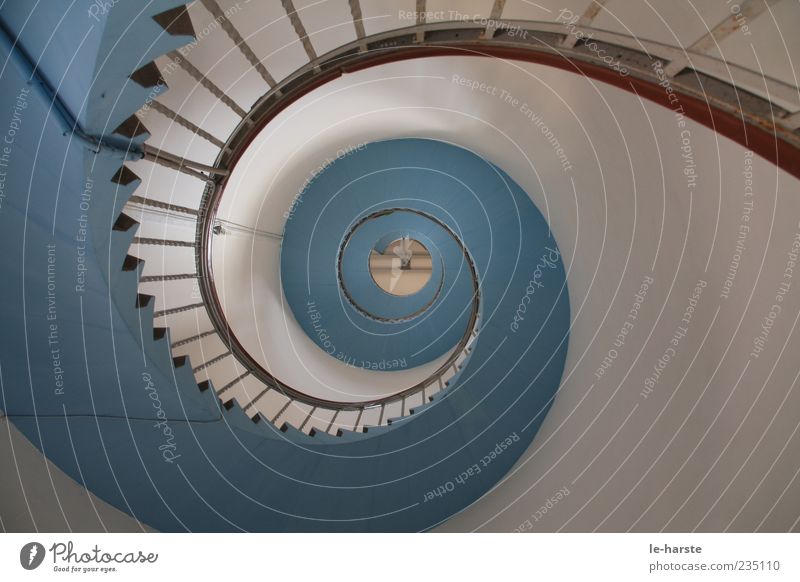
left=138, top=13, right=800, bottom=436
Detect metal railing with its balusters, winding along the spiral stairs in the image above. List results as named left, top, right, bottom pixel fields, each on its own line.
left=126, top=11, right=800, bottom=434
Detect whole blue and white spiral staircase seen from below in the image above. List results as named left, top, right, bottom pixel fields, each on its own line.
left=0, top=0, right=800, bottom=531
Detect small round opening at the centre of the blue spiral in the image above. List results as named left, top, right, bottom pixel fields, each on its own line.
left=369, top=236, right=433, bottom=296
